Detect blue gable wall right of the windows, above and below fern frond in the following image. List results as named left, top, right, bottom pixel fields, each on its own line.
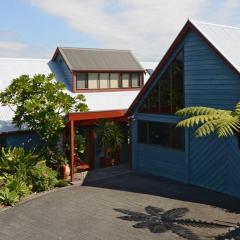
left=184, top=32, right=240, bottom=197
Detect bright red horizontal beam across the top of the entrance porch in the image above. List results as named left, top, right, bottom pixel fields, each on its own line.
left=67, top=110, right=126, bottom=121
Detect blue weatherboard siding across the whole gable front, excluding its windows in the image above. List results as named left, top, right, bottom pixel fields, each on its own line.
left=131, top=31, right=240, bottom=197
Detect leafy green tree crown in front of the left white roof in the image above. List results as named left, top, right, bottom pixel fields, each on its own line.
left=0, top=74, right=88, bottom=144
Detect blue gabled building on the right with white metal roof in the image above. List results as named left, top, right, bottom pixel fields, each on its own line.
left=128, top=20, right=240, bottom=197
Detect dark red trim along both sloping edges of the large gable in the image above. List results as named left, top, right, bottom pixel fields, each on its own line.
left=126, top=20, right=240, bottom=116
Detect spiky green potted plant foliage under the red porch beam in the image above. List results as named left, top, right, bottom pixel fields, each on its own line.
left=97, top=119, right=123, bottom=154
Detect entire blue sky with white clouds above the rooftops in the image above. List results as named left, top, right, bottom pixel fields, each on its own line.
left=0, top=0, right=240, bottom=61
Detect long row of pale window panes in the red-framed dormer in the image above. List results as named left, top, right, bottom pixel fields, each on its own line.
left=76, top=72, right=142, bottom=90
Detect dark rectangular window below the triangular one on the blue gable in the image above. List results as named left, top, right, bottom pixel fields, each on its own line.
left=138, top=121, right=185, bottom=151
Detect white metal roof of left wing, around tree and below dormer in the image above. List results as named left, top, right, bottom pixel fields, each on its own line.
left=0, top=58, right=154, bottom=133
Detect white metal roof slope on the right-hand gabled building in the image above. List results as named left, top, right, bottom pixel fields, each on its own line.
left=189, top=20, right=240, bottom=72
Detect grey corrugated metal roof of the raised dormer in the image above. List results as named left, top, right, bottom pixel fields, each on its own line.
left=58, top=47, right=144, bottom=71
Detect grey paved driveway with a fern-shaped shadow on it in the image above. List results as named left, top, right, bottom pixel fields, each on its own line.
left=0, top=173, right=240, bottom=240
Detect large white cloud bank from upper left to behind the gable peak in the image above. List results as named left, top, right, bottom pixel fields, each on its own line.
left=9, top=0, right=240, bottom=61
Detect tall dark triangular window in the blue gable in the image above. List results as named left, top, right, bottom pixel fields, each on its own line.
left=139, top=50, right=184, bottom=114
